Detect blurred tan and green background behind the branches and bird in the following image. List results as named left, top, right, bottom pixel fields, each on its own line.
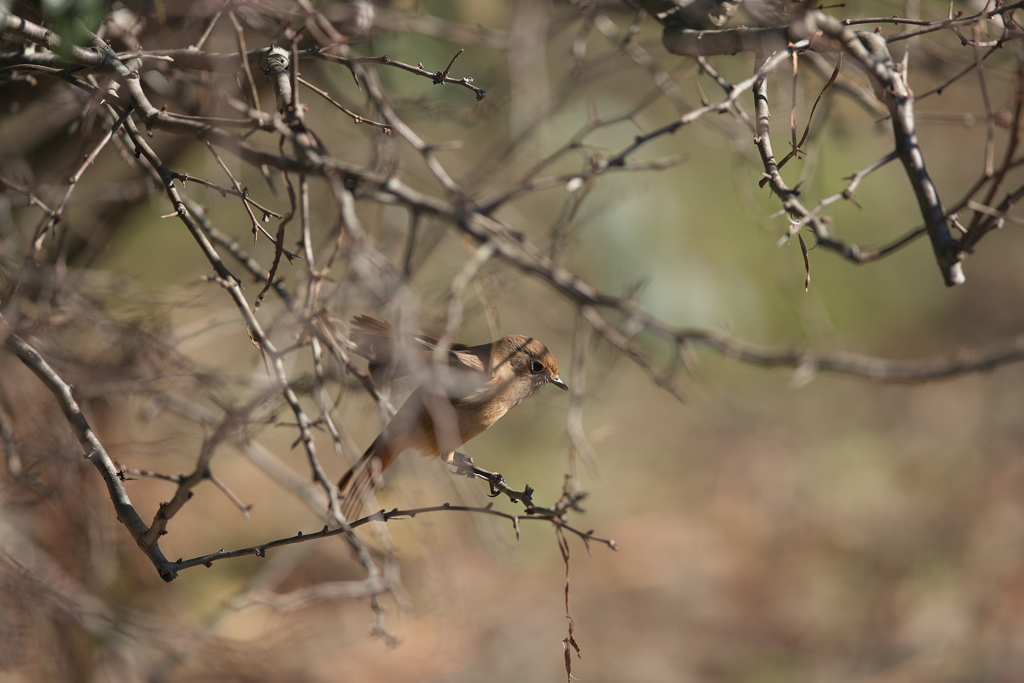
left=0, top=0, right=1024, bottom=683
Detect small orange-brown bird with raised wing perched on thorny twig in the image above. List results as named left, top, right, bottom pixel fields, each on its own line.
left=338, top=315, right=568, bottom=520
